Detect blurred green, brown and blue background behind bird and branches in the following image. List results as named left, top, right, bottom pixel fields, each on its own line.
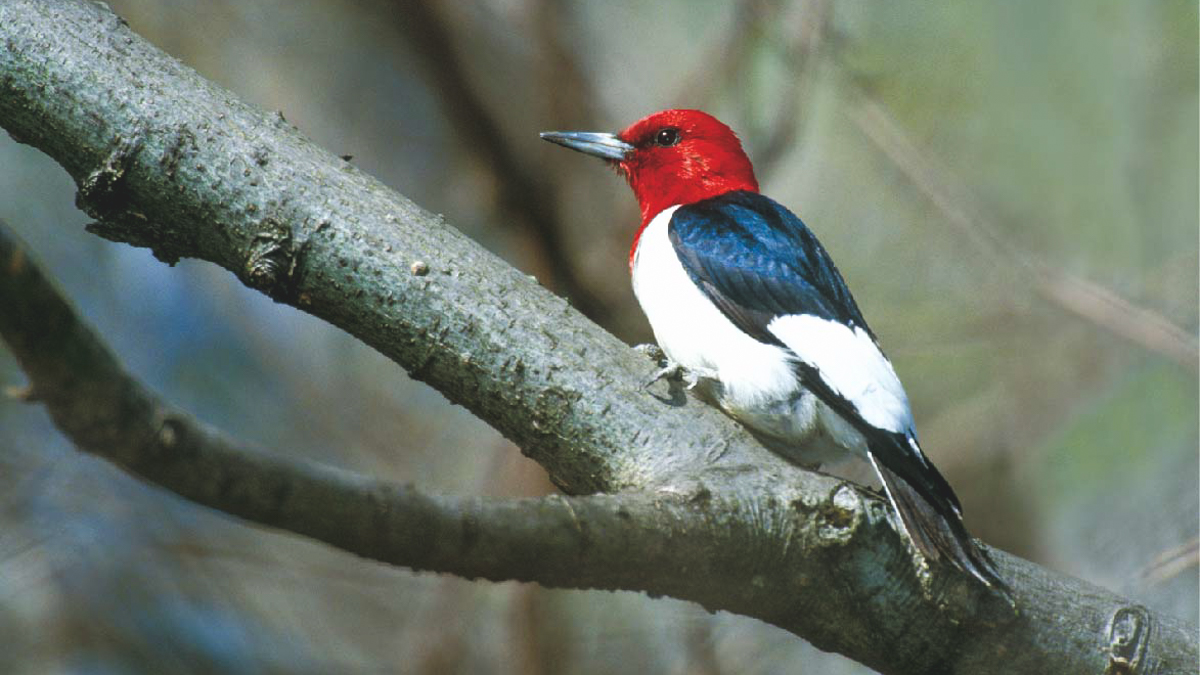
left=0, top=0, right=1200, bottom=674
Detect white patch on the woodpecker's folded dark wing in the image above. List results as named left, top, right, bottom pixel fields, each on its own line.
left=767, top=315, right=912, bottom=434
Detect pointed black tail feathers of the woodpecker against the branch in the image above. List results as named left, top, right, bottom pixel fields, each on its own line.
left=871, top=456, right=1008, bottom=595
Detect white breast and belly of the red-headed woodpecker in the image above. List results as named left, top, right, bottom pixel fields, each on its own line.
left=632, top=207, right=866, bottom=464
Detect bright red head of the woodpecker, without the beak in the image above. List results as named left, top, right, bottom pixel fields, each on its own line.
left=617, top=110, right=758, bottom=227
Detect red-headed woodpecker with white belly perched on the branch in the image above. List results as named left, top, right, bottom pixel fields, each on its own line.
left=540, top=109, right=1007, bottom=591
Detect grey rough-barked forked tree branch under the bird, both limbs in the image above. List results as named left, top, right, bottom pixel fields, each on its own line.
left=0, top=0, right=1195, bottom=674
